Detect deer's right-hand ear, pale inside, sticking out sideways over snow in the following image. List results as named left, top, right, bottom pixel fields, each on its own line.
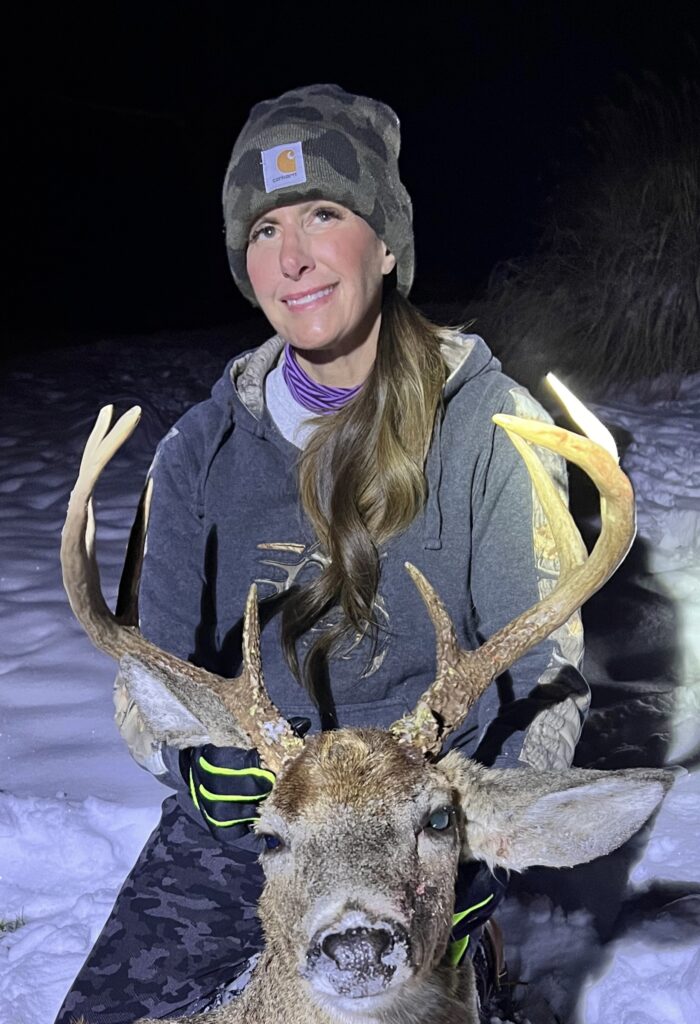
left=450, top=768, right=673, bottom=870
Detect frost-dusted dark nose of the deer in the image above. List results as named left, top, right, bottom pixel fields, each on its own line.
left=303, top=921, right=409, bottom=998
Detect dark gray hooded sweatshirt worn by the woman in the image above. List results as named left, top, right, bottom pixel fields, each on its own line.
left=140, top=334, right=588, bottom=768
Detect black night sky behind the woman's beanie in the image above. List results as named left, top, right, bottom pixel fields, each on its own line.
left=4, top=0, right=700, bottom=346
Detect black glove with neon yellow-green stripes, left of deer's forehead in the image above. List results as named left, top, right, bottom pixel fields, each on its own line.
left=180, top=718, right=311, bottom=842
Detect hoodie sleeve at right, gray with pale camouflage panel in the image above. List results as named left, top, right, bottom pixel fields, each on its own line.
left=471, top=387, right=589, bottom=769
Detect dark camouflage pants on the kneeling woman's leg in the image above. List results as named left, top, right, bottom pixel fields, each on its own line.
left=56, top=794, right=262, bottom=1024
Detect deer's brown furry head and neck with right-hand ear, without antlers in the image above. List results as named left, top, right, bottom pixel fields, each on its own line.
left=120, top=729, right=672, bottom=1024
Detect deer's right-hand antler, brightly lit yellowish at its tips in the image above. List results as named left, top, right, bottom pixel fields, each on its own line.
left=390, top=375, right=635, bottom=755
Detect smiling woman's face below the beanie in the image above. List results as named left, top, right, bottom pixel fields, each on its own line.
left=247, top=201, right=395, bottom=358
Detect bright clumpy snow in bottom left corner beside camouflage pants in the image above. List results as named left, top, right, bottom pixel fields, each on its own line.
left=0, top=794, right=158, bottom=1024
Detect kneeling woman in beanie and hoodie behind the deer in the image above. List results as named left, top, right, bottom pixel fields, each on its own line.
left=57, top=85, right=587, bottom=1024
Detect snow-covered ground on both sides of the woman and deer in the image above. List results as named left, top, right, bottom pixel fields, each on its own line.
left=0, top=333, right=700, bottom=1024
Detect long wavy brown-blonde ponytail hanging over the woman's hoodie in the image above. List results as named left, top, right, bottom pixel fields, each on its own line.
left=282, top=289, right=446, bottom=701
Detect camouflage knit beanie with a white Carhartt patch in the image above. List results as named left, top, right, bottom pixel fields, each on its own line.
left=223, top=85, right=414, bottom=302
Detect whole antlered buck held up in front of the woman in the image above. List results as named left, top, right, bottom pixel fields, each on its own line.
left=61, top=385, right=672, bottom=1024
